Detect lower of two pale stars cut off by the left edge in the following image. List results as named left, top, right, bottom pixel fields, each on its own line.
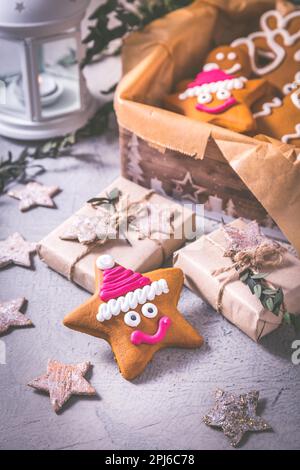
left=0, top=297, right=32, bottom=335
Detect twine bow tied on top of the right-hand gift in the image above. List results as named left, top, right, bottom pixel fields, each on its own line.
left=212, top=241, right=286, bottom=312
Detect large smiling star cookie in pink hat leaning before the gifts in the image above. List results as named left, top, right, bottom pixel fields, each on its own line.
left=64, top=255, right=203, bottom=380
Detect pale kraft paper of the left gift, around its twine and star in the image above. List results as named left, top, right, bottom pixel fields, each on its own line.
left=38, top=177, right=194, bottom=292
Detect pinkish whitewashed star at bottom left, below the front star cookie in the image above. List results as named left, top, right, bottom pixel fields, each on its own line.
left=28, top=359, right=96, bottom=413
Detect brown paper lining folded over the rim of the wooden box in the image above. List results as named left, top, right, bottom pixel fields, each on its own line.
left=115, top=0, right=300, bottom=253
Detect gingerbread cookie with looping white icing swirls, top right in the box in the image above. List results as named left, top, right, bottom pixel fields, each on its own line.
left=231, top=9, right=300, bottom=94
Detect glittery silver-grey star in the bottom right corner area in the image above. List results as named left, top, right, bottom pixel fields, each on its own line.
left=203, top=389, right=272, bottom=447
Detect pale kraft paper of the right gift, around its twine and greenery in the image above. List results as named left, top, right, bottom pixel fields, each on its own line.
left=174, top=219, right=300, bottom=341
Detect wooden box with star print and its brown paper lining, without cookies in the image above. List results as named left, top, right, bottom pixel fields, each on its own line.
left=115, top=0, right=300, bottom=252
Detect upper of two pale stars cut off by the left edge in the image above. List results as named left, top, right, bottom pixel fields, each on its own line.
left=0, top=232, right=36, bottom=268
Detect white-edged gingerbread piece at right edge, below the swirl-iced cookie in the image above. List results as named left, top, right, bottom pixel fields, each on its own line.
left=255, top=83, right=300, bottom=147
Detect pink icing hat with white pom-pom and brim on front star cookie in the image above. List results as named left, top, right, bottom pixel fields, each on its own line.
left=96, top=255, right=169, bottom=321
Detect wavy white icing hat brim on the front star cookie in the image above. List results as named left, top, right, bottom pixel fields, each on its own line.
left=96, top=279, right=169, bottom=322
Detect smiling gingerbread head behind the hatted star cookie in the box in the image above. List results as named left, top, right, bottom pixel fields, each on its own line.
left=203, top=46, right=252, bottom=78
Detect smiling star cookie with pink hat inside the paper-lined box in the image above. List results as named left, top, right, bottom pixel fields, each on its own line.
left=165, top=69, right=268, bottom=132
